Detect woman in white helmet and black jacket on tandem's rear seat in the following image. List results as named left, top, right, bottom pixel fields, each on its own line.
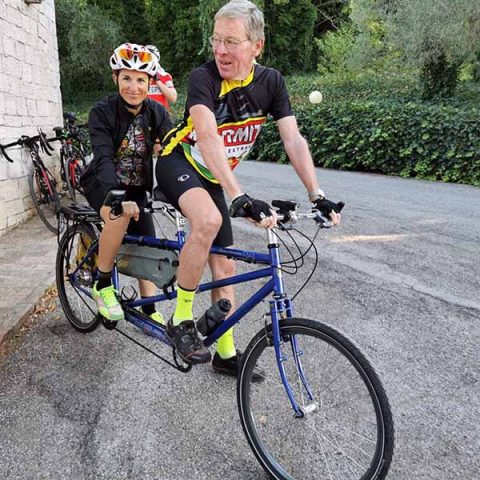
left=80, top=43, right=172, bottom=323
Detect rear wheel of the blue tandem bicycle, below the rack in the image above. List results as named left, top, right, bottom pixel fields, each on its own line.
left=56, top=220, right=100, bottom=333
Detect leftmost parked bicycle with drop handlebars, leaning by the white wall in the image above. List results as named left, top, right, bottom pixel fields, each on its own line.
left=0, top=130, right=61, bottom=233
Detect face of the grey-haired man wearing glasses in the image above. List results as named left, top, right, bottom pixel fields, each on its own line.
left=212, top=18, right=263, bottom=80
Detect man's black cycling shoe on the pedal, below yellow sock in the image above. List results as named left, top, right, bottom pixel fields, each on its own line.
left=166, top=319, right=212, bottom=364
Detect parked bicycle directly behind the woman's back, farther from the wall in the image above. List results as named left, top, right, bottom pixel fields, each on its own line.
left=53, top=112, right=87, bottom=202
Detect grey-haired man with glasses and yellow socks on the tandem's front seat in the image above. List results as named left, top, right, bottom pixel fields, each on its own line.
left=156, top=0, right=341, bottom=375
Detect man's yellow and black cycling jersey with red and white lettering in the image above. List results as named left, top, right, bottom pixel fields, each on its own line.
left=161, top=61, right=292, bottom=183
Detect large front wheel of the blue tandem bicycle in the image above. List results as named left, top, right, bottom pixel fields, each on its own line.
left=237, top=318, right=394, bottom=480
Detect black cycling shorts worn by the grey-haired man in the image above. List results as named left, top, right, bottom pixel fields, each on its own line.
left=155, top=150, right=233, bottom=247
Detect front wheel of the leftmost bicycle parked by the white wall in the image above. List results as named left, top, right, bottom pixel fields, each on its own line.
left=28, top=166, right=60, bottom=233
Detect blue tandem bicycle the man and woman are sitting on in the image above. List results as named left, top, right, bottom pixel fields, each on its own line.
left=56, top=192, right=394, bottom=480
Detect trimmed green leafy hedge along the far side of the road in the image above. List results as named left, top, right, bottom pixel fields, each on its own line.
left=251, top=86, right=480, bottom=185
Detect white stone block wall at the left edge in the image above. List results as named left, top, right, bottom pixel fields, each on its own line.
left=0, top=0, right=62, bottom=235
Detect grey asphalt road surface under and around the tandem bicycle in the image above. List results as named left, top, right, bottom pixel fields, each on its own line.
left=0, top=162, right=480, bottom=480
